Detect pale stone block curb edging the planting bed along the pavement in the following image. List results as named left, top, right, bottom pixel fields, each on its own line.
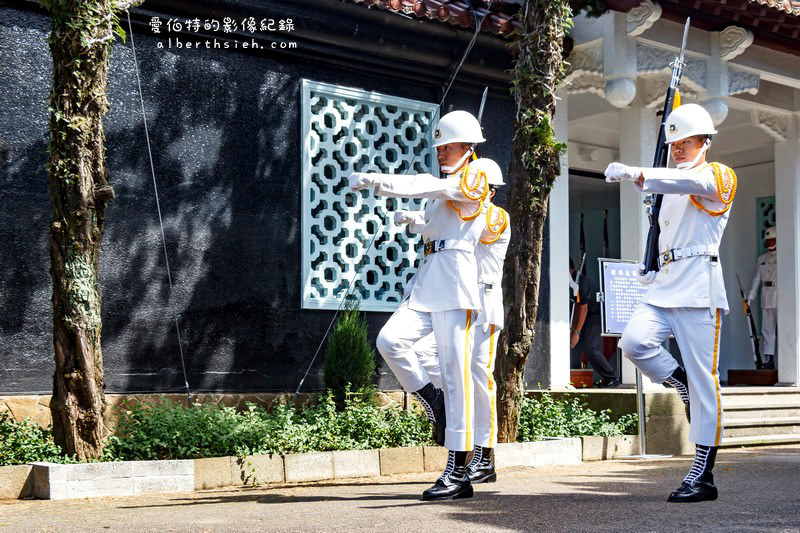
left=0, top=438, right=592, bottom=500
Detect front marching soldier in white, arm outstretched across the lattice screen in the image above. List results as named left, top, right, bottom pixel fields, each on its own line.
left=350, top=111, right=489, bottom=500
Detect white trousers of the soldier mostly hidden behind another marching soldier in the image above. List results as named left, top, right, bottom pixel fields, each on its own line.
left=414, top=324, right=500, bottom=448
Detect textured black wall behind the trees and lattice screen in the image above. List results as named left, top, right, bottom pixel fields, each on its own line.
left=0, top=7, right=548, bottom=394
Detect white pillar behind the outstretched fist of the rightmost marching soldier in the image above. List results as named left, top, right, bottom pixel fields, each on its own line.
left=619, top=91, right=659, bottom=385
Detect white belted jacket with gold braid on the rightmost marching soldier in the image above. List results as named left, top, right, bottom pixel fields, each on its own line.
left=636, top=163, right=736, bottom=313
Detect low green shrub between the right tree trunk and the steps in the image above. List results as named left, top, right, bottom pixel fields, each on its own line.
left=517, top=392, right=638, bottom=442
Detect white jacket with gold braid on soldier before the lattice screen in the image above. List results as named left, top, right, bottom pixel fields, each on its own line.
left=375, top=173, right=488, bottom=313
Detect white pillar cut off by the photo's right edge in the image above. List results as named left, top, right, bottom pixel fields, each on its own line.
left=775, top=115, right=800, bottom=386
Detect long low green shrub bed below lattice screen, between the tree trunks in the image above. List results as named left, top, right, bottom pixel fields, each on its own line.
left=105, top=388, right=430, bottom=460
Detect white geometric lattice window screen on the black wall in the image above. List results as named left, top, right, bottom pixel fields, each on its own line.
left=302, top=80, right=438, bottom=311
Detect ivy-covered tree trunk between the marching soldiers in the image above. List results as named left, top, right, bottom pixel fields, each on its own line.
left=495, top=0, right=570, bottom=442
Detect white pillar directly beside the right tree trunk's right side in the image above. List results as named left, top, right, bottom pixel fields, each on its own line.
left=542, top=89, right=570, bottom=387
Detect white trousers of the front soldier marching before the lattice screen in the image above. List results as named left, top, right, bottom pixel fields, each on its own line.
left=376, top=300, right=474, bottom=452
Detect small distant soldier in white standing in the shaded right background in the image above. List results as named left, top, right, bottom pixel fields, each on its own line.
left=747, top=226, right=778, bottom=369
